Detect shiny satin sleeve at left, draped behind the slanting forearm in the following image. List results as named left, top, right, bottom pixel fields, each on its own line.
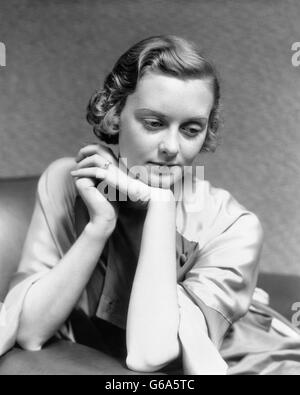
left=0, top=158, right=75, bottom=355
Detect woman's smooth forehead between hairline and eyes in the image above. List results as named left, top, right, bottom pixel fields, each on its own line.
left=128, top=73, right=214, bottom=117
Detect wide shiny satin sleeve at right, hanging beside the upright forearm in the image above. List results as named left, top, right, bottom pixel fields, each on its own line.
left=178, top=183, right=263, bottom=374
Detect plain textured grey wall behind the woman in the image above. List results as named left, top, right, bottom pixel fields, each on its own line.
left=0, top=0, right=300, bottom=274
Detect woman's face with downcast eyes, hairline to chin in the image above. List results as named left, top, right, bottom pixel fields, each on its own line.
left=119, top=72, right=214, bottom=188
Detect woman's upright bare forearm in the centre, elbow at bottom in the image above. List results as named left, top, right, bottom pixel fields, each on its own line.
left=127, top=193, right=180, bottom=371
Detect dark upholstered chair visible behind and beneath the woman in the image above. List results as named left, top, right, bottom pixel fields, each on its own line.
left=0, top=177, right=300, bottom=375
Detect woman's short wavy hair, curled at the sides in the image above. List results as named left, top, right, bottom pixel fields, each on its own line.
left=87, top=35, right=220, bottom=151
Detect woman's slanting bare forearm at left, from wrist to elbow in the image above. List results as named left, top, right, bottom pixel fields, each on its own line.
left=17, top=223, right=109, bottom=350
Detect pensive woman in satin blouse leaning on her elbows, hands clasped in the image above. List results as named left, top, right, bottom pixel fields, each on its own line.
left=0, top=36, right=299, bottom=374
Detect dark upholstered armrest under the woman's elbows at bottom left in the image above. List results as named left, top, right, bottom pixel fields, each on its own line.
left=0, top=341, right=163, bottom=375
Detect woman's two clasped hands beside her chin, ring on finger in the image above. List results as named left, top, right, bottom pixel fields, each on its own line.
left=71, top=144, right=174, bottom=234
